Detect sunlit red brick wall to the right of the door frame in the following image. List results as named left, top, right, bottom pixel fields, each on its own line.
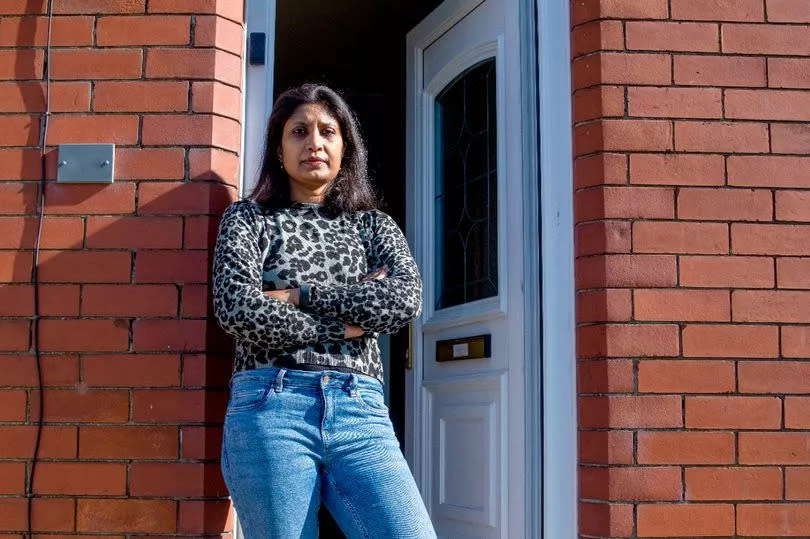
left=571, top=0, right=810, bottom=537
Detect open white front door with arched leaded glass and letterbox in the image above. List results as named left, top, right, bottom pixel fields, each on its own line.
left=406, top=0, right=524, bottom=538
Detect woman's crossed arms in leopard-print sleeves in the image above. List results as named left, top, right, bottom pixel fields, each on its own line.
left=213, top=201, right=422, bottom=349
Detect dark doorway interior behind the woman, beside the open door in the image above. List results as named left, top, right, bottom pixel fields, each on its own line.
left=274, top=0, right=441, bottom=538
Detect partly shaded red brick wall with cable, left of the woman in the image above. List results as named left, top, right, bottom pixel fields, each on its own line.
left=0, top=0, right=243, bottom=538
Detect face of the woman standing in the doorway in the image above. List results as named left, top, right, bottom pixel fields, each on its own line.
left=279, top=104, right=343, bottom=194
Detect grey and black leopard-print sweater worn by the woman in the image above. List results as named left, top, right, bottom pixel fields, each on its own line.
left=213, top=200, right=422, bottom=380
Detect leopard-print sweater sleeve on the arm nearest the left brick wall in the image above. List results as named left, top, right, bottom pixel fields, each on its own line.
left=213, top=201, right=345, bottom=349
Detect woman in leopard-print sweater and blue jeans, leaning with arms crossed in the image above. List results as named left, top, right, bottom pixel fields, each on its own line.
left=213, top=85, right=436, bottom=539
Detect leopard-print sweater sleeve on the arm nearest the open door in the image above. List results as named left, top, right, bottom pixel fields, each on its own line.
left=307, top=210, right=422, bottom=333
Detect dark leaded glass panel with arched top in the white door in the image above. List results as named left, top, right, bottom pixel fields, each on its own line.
left=434, top=58, right=498, bottom=310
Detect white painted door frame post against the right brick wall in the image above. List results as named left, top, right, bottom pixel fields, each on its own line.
left=522, top=0, right=578, bottom=539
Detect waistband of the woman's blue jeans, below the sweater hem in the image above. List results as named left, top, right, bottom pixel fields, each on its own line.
left=230, top=367, right=383, bottom=391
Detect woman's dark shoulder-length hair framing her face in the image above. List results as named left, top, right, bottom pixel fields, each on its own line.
left=250, top=84, right=379, bottom=215
